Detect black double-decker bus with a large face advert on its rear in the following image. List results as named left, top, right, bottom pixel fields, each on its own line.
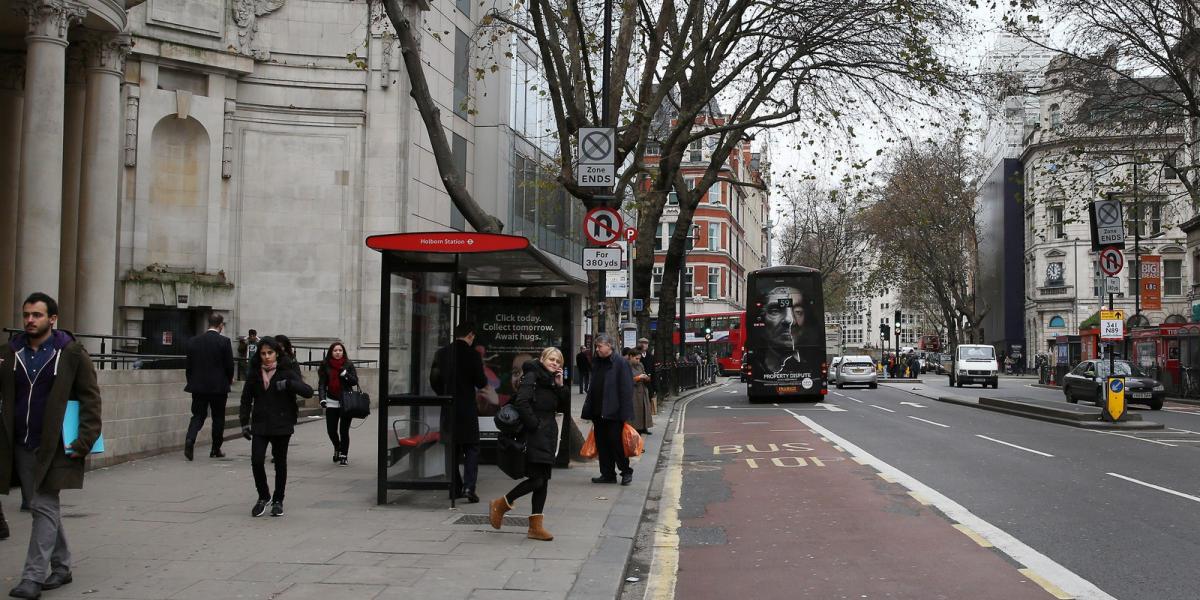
left=746, top=274, right=826, bottom=395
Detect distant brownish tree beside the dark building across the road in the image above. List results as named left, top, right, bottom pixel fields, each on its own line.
left=865, top=132, right=989, bottom=347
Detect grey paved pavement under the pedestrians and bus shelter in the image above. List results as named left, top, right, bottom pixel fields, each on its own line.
left=0, top=386, right=688, bottom=600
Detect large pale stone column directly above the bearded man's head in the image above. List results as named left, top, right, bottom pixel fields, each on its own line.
left=8, top=0, right=86, bottom=323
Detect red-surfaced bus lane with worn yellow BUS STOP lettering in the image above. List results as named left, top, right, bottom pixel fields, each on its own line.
left=674, top=412, right=1054, bottom=600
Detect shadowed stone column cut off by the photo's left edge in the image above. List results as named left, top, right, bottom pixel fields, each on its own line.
left=0, top=54, right=25, bottom=328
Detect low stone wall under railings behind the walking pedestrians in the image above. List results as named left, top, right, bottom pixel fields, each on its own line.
left=88, top=368, right=379, bottom=468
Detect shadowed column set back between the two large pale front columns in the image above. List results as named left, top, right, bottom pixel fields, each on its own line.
left=58, top=46, right=88, bottom=331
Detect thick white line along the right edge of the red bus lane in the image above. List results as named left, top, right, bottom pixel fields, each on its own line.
left=796, top=415, right=1116, bottom=600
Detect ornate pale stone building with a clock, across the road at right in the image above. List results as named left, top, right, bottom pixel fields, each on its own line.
left=1021, top=58, right=1193, bottom=352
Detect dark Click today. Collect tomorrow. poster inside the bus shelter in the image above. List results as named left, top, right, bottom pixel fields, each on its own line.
left=467, top=296, right=574, bottom=438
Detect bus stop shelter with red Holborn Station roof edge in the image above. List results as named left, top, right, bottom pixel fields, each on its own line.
left=366, top=232, right=578, bottom=506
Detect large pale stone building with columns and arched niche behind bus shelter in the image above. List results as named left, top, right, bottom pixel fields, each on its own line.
left=0, top=0, right=586, bottom=358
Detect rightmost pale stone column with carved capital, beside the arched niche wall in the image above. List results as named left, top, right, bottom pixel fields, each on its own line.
left=76, top=35, right=130, bottom=349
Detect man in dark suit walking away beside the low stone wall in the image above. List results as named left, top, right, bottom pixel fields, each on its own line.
left=184, top=313, right=234, bottom=461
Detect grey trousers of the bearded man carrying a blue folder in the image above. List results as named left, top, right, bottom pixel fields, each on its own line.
left=13, top=446, right=71, bottom=583
